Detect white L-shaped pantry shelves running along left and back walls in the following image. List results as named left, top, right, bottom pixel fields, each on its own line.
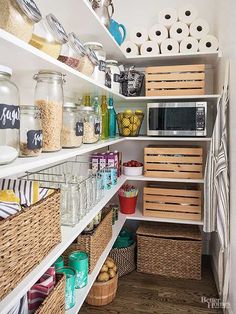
left=0, top=0, right=221, bottom=314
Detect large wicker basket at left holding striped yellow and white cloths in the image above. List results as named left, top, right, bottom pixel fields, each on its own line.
left=0, top=191, right=61, bottom=299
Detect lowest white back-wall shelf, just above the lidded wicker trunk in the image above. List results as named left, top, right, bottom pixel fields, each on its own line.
left=126, top=205, right=203, bottom=226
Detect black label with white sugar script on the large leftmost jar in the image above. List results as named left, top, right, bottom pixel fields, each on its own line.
left=0, top=104, right=20, bottom=129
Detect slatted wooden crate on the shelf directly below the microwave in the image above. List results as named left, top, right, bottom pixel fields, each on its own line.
left=144, top=146, right=203, bottom=179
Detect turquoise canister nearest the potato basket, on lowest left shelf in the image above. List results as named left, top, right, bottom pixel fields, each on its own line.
left=69, top=251, right=88, bottom=289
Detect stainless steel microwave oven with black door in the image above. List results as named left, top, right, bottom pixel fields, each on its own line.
left=147, top=102, right=207, bottom=136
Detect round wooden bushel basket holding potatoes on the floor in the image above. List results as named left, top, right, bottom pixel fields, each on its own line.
left=85, top=274, right=118, bottom=306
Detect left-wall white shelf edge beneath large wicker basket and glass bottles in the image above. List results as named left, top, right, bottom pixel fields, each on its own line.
left=0, top=176, right=126, bottom=314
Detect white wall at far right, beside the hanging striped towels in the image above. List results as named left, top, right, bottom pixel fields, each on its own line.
left=216, top=0, right=236, bottom=313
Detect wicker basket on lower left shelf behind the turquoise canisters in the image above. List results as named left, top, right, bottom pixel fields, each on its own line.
left=63, top=209, right=112, bottom=273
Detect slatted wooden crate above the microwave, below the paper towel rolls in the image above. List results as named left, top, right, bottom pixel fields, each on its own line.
left=145, top=64, right=205, bottom=96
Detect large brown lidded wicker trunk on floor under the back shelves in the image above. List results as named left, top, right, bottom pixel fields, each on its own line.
left=137, top=223, right=202, bottom=280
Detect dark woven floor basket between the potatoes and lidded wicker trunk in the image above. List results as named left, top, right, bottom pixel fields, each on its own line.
left=109, top=243, right=136, bottom=277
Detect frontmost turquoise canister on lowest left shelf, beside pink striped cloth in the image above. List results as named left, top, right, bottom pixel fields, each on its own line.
left=57, top=267, right=76, bottom=310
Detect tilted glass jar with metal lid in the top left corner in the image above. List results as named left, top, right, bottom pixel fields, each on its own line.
left=0, top=0, right=42, bottom=43
